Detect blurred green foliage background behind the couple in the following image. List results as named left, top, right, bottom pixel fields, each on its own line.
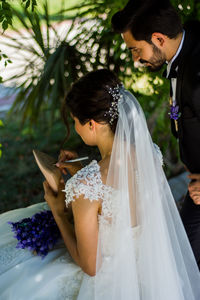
left=0, top=0, right=200, bottom=211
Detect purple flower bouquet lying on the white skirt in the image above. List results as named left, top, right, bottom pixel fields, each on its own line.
left=8, top=210, right=61, bottom=258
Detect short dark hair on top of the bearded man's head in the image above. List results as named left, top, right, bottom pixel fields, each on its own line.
left=112, top=0, right=183, bottom=43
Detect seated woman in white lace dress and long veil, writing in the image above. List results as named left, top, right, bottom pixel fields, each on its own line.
left=0, top=69, right=200, bottom=300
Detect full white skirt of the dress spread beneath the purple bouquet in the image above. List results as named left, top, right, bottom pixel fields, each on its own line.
left=0, top=203, right=85, bottom=300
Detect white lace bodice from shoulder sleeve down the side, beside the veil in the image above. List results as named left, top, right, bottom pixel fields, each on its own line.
left=64, top=160, right=140, bottom=262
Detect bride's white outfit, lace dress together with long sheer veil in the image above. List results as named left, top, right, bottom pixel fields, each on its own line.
left=0, top=87, right=200, bottom=300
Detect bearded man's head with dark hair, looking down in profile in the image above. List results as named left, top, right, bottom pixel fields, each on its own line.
left=112, top=0, right=183, bottom=71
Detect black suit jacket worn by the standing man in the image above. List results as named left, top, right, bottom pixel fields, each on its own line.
left=172, top=23, right=200, bottom=173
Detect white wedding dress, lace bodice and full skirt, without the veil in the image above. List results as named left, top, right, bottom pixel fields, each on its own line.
left=0, top=160, right=137, bottom=300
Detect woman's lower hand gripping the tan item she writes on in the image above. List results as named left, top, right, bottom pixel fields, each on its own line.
left=43, top=181, right=67, bottom=216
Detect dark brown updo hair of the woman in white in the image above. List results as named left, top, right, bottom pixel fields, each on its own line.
left=62, top=69, right=121, bottom=133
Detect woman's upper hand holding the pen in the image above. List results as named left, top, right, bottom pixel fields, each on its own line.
left=56, top=150, right=83, bottom=176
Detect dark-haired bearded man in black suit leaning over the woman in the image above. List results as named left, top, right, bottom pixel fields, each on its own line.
left=112, top=0, right=200, bottom=268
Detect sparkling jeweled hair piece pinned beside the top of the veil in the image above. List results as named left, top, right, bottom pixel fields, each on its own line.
left=104, top=84, right=123, bottom=125
